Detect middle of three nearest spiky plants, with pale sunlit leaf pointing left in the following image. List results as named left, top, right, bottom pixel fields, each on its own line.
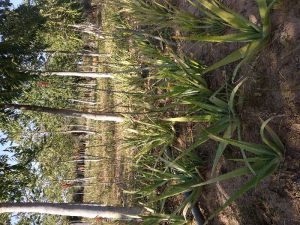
left=166, top=79, right=246, bottom=173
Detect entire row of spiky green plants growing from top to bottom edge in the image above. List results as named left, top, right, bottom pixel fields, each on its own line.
left=101, top=0, right=284, bottom=224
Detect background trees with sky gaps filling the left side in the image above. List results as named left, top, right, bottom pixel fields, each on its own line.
left=0, top=0, right=115, bottom=225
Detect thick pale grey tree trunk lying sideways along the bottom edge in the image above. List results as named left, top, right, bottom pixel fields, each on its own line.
left=0, top=203, right=142, bottom=220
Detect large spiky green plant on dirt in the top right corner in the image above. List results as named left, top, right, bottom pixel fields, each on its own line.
left=177, top=0, right=276, bottom=80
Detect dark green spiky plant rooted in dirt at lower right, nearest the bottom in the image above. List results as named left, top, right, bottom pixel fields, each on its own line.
left=192, top=118, right=284, bottom=224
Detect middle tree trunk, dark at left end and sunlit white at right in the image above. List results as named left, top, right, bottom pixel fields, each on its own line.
left=0, top=104, right=124, bottom=123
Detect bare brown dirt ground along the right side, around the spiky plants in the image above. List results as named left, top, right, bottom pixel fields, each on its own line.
left=177, top=0, right=300, bottom=225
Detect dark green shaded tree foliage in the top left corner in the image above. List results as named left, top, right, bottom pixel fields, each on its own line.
left=0, top=5, right=46, bottom=101
